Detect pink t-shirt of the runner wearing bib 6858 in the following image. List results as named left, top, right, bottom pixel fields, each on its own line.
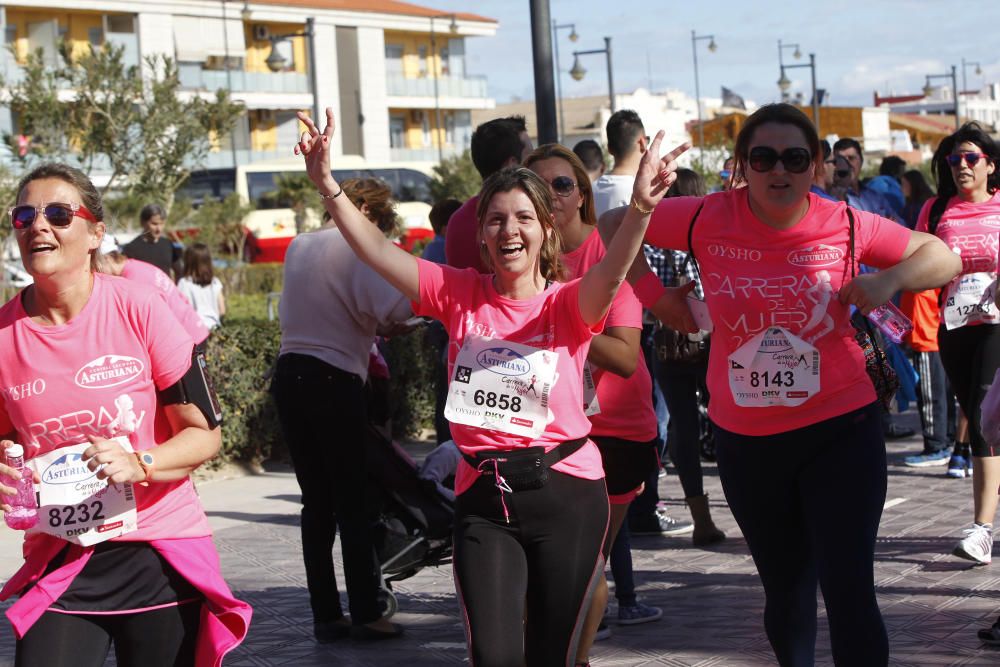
left=413, top=260, right=604, bottom=493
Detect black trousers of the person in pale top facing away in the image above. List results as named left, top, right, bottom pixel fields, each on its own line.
left=272, top=354, right=381, bottom=625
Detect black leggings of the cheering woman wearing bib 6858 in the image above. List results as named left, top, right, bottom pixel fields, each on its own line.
left=453, top=470, right=608, bottom=667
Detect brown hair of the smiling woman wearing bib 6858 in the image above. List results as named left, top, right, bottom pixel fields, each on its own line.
left=476, top=167, right=563, bottom=280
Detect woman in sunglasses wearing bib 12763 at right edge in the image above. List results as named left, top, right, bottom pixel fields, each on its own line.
left=916, top=123, right=1000, bottom=564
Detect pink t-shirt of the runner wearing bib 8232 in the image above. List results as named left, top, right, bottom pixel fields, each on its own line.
left=0, top=273, right=211, bottom=545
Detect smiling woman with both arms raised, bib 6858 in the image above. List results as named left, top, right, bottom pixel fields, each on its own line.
left=296, top=109, right=676, bottom=667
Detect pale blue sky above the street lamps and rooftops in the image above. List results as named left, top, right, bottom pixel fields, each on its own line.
left=424, top=0, right=1000, bottom=105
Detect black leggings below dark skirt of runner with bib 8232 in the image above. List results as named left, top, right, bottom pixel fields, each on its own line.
left=14, top=602, right=201, bottom=667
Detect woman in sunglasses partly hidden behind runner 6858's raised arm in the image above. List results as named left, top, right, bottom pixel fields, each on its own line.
left=524, top=144, right=662, bottom=664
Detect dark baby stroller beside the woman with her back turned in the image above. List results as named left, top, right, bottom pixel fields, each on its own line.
left=367, top=426, right=454, bottom=618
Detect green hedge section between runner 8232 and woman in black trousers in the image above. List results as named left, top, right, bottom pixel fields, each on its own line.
left=206, top=319, right=286, bottom=463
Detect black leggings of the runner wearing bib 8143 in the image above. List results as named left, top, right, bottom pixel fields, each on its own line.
left=715, top=403, right=889, bottom=667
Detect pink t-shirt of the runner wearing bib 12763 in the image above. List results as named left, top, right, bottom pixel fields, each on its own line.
left=916, top=191, right=1000, bottom=325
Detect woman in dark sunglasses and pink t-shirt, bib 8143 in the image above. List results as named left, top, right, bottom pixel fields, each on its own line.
left=608, top=104, right=959, bottom=667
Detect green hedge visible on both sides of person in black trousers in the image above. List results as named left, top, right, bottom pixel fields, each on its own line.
left=207, top=319, right=434, bottom=463
